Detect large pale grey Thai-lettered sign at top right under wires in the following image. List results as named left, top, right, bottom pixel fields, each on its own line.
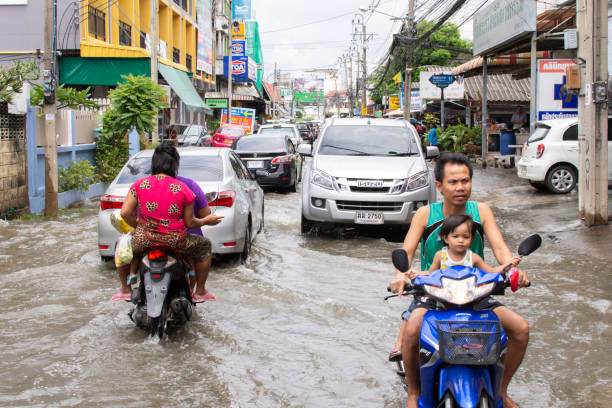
left=474, top=0, right=537, bottom=55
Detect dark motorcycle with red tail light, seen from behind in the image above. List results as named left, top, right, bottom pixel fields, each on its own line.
left=128, top=246, right=194, bottom=342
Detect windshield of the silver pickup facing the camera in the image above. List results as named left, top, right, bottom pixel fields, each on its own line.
left=318, top=125, right=420, bottom=156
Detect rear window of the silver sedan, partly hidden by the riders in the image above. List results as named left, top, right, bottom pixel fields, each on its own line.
left=117, top=156, right=223, bottom=184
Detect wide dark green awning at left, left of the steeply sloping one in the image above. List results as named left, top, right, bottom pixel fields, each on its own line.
left=59, top=57, right=151, bottom=86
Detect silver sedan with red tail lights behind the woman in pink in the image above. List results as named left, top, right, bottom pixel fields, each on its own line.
left=98, top=147, right=264, bottom=261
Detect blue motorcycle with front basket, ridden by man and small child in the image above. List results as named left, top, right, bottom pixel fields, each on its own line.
left=385, top=234, right=542, bottom=408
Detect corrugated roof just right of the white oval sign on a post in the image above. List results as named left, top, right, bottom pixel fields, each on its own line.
left=463, top=74, right=531, bottom=103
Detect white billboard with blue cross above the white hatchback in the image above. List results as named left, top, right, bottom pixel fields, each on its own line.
left=536, top=59, right=578, bottom=120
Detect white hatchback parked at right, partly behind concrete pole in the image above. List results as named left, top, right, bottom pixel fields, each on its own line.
left=517, top=118, right=612, bottom=194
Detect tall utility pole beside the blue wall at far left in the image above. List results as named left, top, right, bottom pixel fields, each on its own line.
left=43, top=0, right=58, bottom=217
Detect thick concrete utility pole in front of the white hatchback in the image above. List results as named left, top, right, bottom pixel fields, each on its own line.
left=576, top=0, right=609, bottom=226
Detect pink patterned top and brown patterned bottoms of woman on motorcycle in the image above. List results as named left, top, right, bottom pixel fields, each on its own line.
left=128, top=174, right=211, bottom=261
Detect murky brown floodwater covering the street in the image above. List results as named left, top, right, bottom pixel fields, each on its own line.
left=0, top=169, right=612, bottom=408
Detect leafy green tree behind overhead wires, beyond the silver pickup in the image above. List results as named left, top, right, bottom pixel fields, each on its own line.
left=368, top=21, right=472, bottom=103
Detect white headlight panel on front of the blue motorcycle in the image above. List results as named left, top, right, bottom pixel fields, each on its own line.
left=423, top=276, right=495, bottom=306
